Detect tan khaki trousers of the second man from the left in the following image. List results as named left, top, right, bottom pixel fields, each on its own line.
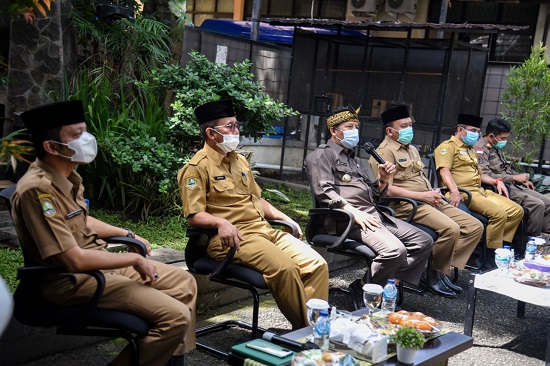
left=208, top=221, right=328, bottom=329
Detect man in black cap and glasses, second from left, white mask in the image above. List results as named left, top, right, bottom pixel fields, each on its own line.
left=178, top=100, right=328, bottom=329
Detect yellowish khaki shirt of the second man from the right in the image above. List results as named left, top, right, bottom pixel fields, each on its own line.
left=434, top=136, right=483, bottom=192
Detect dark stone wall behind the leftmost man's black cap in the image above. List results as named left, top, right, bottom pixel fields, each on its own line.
left=3, top=0, right=76, bottom=135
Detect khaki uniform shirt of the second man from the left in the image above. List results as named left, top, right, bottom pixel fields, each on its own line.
left=178, top=144, right=265, bottom=227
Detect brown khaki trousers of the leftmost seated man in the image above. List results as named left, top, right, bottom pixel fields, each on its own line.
left=53, top=262, right=197, bottom=366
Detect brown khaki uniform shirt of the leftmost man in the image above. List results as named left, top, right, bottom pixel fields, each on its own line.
left=11, top=159, right=107, bottom=265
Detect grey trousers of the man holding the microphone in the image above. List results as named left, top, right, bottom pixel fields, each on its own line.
left=349, top=219, right=433, bottom=286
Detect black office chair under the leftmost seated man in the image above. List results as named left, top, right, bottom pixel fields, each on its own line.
left=0, top=186, right=151, bottom=365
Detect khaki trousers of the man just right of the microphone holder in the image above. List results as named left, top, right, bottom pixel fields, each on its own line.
left=395, top=203, right=483, bottom=274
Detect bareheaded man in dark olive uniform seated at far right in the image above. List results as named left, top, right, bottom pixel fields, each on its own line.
left=475, top=117, right=550, bottom=236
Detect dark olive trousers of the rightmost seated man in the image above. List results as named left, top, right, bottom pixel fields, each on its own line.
left=510, top=186, right=550, bottom=236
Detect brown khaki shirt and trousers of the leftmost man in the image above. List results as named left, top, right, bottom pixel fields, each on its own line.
left=11, top=159, right=197, bottom=365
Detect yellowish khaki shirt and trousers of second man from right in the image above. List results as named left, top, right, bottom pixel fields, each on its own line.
left=434, top=136, right=523, bottom=249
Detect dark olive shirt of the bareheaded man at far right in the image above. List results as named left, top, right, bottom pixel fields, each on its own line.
left=474, top=137, right=526, bottom=189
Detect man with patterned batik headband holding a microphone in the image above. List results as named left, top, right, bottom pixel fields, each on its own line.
left=305, top=104, right=433, bottom=308
